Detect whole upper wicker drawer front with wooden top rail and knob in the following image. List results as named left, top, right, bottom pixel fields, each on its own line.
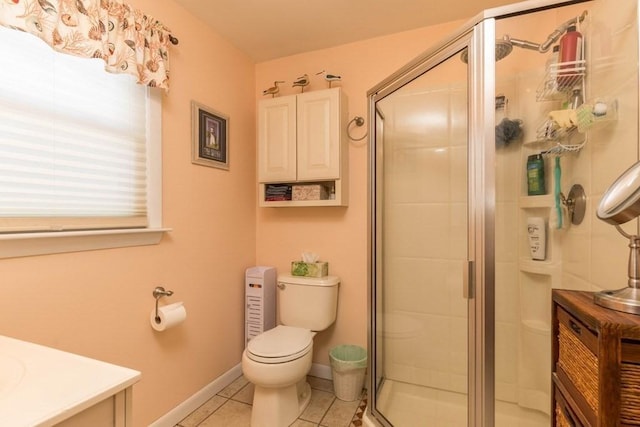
left=557, top=308, right=599, bottom=417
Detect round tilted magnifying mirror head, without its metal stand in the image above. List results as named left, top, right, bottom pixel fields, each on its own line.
left=596, top=162, right=640, bottom=225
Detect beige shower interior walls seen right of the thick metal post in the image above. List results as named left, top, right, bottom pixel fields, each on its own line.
left=496, top=0, right=638, bottom=413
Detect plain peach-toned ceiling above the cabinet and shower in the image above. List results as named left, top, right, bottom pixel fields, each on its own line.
left=175, top=0, right=516, bottom=62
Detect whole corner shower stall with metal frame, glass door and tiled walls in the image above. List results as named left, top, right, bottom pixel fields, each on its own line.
left=365, top=0, right=639, bottom=427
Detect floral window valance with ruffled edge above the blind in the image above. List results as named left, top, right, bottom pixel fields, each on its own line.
left=0, top=0, right=175, bottom=89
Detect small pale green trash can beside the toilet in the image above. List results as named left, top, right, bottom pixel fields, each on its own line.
left=329, top=344, right=367, bottom=402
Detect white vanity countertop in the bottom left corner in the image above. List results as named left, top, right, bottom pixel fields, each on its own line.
left=0, top=336, right=141, bottom=427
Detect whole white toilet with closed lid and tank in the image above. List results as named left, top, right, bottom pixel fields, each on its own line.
left=242, top=275, right=340, bottom=427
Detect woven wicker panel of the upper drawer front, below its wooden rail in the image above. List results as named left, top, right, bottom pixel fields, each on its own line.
left=558, top=324, right=598, bottom=416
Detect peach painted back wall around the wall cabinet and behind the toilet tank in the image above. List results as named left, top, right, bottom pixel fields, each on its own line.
left=256, top=21, right=462, bottom=365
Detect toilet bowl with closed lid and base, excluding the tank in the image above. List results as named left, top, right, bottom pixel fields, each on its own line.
left=242, top=326, right=315, bottom=427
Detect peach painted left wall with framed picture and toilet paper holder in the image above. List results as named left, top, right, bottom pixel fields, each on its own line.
left=0, top=0, right=256, bottom=426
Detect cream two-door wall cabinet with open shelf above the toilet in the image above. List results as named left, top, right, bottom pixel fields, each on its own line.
left=258, top=88, right=348, bottom=206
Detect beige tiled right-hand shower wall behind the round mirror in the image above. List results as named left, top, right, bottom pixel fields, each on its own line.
left=562, top=0, right=639, bottom=291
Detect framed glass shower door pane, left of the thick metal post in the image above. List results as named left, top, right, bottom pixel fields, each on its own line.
left=370, top=46, right=469, bottom=427
